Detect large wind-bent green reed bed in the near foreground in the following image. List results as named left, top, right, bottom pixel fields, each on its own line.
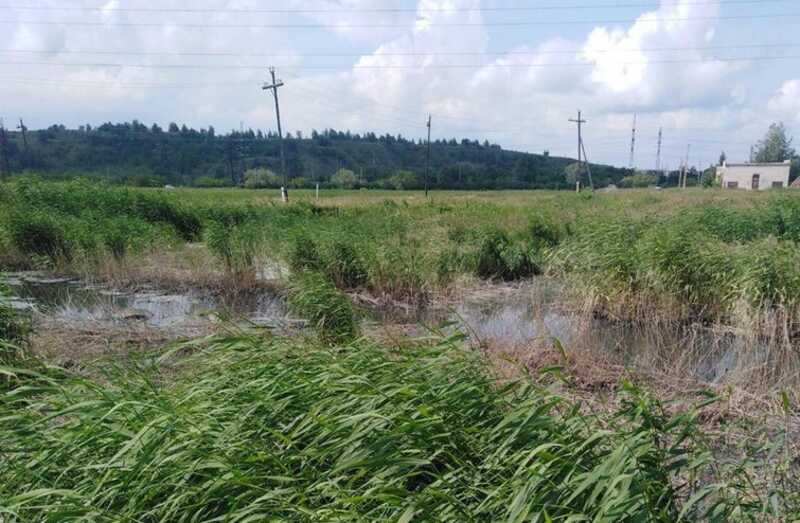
left=0, top=333, right=798, bottom=523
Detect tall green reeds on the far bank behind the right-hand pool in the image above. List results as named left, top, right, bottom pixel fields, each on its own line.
left=548, top=198, right=800, bottom=323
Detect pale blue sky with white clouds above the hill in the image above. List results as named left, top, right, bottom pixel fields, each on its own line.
left=0, top=0, right=800, bottom=168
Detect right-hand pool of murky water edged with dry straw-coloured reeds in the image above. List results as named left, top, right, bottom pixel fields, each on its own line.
left=381, top=278, right=752, bottom=383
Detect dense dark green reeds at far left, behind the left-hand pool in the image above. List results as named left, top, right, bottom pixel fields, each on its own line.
left=0, top=181, right=201, bottom=273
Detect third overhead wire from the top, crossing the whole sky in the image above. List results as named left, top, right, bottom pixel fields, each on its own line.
left=0, top=43, right=800, bottom=58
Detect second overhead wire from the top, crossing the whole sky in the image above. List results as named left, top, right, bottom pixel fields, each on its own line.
left=0, top=13, right=800, bottom=29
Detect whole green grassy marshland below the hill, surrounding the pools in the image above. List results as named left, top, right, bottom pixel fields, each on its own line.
left=0, top=182, right=800, bottom=522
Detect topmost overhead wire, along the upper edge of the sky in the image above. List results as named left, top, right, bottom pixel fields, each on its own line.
left=0, top=0, right=791, bottom=14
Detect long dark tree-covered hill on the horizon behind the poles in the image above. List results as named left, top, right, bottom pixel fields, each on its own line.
left=0, top=121, right=630, bottom=189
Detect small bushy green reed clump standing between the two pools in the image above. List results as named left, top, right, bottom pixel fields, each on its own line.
left=289, top=273, right=358, bottom=344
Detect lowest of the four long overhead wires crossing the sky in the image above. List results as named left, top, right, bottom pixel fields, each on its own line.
left=0, top=54, right=800, bottom=71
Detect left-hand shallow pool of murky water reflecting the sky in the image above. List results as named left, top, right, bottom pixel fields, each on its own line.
left=5, top=273, right=287, bottom=327
